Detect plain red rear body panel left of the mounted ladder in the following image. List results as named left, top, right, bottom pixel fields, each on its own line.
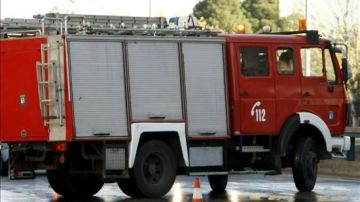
left=0, top=38, right=48, bottom=142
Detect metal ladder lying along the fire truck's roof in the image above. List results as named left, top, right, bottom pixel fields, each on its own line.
left=0, top=14, right=218, bottom=38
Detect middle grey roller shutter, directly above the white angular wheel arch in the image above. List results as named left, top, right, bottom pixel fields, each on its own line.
left=128, top=41, right=183, bottom=121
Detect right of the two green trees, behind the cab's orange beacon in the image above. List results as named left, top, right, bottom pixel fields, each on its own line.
left=242, top=0, right=280, bottom=32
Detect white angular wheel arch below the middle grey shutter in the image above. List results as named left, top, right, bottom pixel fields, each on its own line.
left=129, top=123, right=189, bottom=168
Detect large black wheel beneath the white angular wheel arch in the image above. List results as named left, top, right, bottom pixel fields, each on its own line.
left=133, top=140, right=177, bottom=198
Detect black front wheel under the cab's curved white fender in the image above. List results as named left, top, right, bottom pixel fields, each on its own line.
left=292, top=137, right=319, bottom=192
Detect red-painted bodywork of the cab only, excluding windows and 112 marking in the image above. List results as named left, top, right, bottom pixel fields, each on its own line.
left=224, top=35, right=346, bottom=135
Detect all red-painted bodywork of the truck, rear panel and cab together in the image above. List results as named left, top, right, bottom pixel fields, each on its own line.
left=0, top=35, right=345, bottom=142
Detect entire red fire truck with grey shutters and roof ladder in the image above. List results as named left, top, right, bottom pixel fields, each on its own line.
left=0, top=14, right=350, bottom=197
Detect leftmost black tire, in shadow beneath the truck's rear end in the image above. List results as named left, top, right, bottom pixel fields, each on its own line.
left=46, top=169, right=104, bottom=197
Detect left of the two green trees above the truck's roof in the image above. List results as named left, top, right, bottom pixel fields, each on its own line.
left=194, top=0, right=251, bottom=33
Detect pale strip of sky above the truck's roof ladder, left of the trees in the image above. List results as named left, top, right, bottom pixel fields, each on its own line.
left=0, top=0, right=199, bottom=19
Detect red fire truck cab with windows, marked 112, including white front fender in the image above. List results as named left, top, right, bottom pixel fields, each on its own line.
left=225, top=31, right=346, bottom=151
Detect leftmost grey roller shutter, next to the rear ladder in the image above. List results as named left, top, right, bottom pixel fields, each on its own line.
left=68, top=41, right=128, bottom=137
